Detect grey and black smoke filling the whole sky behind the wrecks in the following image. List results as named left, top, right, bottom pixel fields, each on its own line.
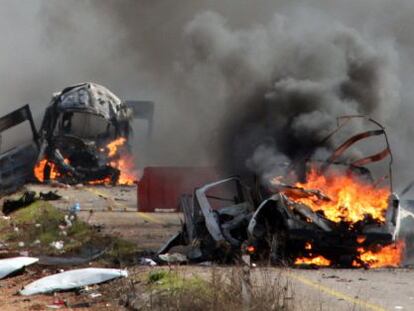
left=0, top=0, right=414, bottom=193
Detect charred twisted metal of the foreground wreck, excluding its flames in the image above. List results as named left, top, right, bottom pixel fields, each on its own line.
left=159, top=116, right=400, bottom=266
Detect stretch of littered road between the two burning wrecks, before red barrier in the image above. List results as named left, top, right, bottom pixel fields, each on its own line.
left=28, top=185, right=181, bottom=251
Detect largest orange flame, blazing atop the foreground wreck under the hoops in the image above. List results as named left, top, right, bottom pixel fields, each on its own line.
left=285, top=169, right=390, bottom=223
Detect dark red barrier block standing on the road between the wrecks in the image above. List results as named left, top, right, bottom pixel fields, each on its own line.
left=137, top=167, right=219, bottom=212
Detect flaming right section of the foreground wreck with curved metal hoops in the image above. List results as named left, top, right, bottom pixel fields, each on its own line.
left=248, top=117, right=400, bottom=266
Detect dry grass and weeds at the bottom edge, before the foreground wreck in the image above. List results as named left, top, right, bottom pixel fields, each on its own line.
left=120, top=267, right=294, bottom=311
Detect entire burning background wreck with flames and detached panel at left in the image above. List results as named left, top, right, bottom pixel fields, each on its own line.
left=0, top=83, right=154, bottom=194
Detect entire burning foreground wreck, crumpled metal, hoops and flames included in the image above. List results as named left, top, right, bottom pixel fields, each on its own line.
left=159, top=117, right=403, bottom=267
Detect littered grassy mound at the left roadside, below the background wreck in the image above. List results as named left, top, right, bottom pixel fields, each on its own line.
left=0, top=200, right=137, bottom=264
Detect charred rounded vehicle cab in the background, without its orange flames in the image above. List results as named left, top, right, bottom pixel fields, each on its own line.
left=39, top=83, right=153, bottom=184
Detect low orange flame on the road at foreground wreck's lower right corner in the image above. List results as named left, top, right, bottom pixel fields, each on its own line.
left=352, top=241, right=405, bottom=268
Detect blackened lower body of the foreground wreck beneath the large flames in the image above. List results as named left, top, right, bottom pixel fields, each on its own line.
left=248, top=194, right=400, bottom=267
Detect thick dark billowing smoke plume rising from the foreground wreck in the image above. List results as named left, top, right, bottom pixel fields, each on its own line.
left=180, top=11, right=400, bottom=180
